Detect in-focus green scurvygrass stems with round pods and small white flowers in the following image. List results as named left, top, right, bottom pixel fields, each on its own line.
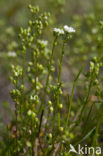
left=0, top=5, right=103, bottom=156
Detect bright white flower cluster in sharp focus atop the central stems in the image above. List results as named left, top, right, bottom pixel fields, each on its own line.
left=53, top=25, right=75, bottom=36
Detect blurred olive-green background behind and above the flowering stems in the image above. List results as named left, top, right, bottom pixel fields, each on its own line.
left=0, top=0, right=103, bottom=134
